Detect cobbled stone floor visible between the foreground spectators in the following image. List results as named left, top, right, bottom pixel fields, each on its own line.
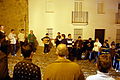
left=8, top=47, right=120, bottom=80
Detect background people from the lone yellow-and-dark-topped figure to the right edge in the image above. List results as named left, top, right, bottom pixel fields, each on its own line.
left=42, top=32, right=120, bottom=71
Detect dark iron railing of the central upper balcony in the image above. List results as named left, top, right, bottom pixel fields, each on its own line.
left=72, top=11, right=88, bottom=24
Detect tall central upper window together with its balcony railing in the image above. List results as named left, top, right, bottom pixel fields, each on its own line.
left=72, top=0, right=88, bottom=24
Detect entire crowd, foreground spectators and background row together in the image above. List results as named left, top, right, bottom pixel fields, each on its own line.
left=0, top=25, right=120, bottom=80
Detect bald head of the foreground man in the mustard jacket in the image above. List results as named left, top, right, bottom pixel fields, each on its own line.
left=57, top=44, right=68, bottom=57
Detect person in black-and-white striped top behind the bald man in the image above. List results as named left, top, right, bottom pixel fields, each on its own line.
left=67, top=34, right=74, bottom=61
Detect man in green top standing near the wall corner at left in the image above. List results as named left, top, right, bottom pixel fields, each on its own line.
left=28, top=30, right=36, bottom=52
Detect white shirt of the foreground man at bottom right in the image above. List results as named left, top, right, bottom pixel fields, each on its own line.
left=86, top=71, right=115, bottom=80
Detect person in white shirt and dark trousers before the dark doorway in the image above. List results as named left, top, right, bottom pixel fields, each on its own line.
left=92, top=38, right=102, bottom=62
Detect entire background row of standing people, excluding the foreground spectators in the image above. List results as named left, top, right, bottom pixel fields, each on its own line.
left=1, top=26, right=120, bottom=70
